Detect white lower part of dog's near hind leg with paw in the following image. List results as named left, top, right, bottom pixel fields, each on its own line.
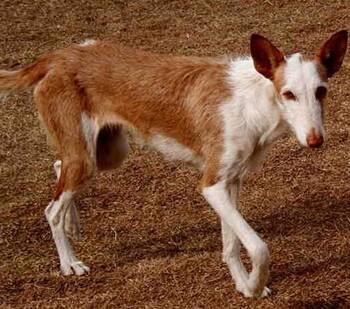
left=45, top=191, right=90, bottom=276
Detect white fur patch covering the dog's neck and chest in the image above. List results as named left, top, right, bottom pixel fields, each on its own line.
left=220, top=58, right=285, bottom=178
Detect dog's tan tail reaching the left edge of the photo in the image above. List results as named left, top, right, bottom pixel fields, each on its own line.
left=0, top=56, right=50, bottom=97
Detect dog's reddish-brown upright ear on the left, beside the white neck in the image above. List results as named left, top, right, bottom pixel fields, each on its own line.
left=250, top=34, right=285, bottom=80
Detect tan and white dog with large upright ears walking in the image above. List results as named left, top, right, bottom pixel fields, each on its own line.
left=0, top=30, right=348, bottom=297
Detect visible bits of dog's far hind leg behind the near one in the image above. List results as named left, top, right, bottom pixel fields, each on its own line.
left=53, top=160, right=81, bottom=240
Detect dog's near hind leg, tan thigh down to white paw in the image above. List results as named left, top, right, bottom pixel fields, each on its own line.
left=34, top=68, right=98, bottom=275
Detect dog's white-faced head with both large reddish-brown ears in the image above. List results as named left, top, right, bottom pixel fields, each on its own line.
left=250, top=30, right=348, bottom=147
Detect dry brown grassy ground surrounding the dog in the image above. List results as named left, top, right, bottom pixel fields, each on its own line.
left=0, top=0, right=350, bottom=308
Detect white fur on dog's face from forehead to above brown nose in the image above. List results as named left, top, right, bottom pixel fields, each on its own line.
left=280, top=54, right=327, bottom=146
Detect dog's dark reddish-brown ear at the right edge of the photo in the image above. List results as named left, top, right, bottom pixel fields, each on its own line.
left=316, top=30, right=348, bottom=77
